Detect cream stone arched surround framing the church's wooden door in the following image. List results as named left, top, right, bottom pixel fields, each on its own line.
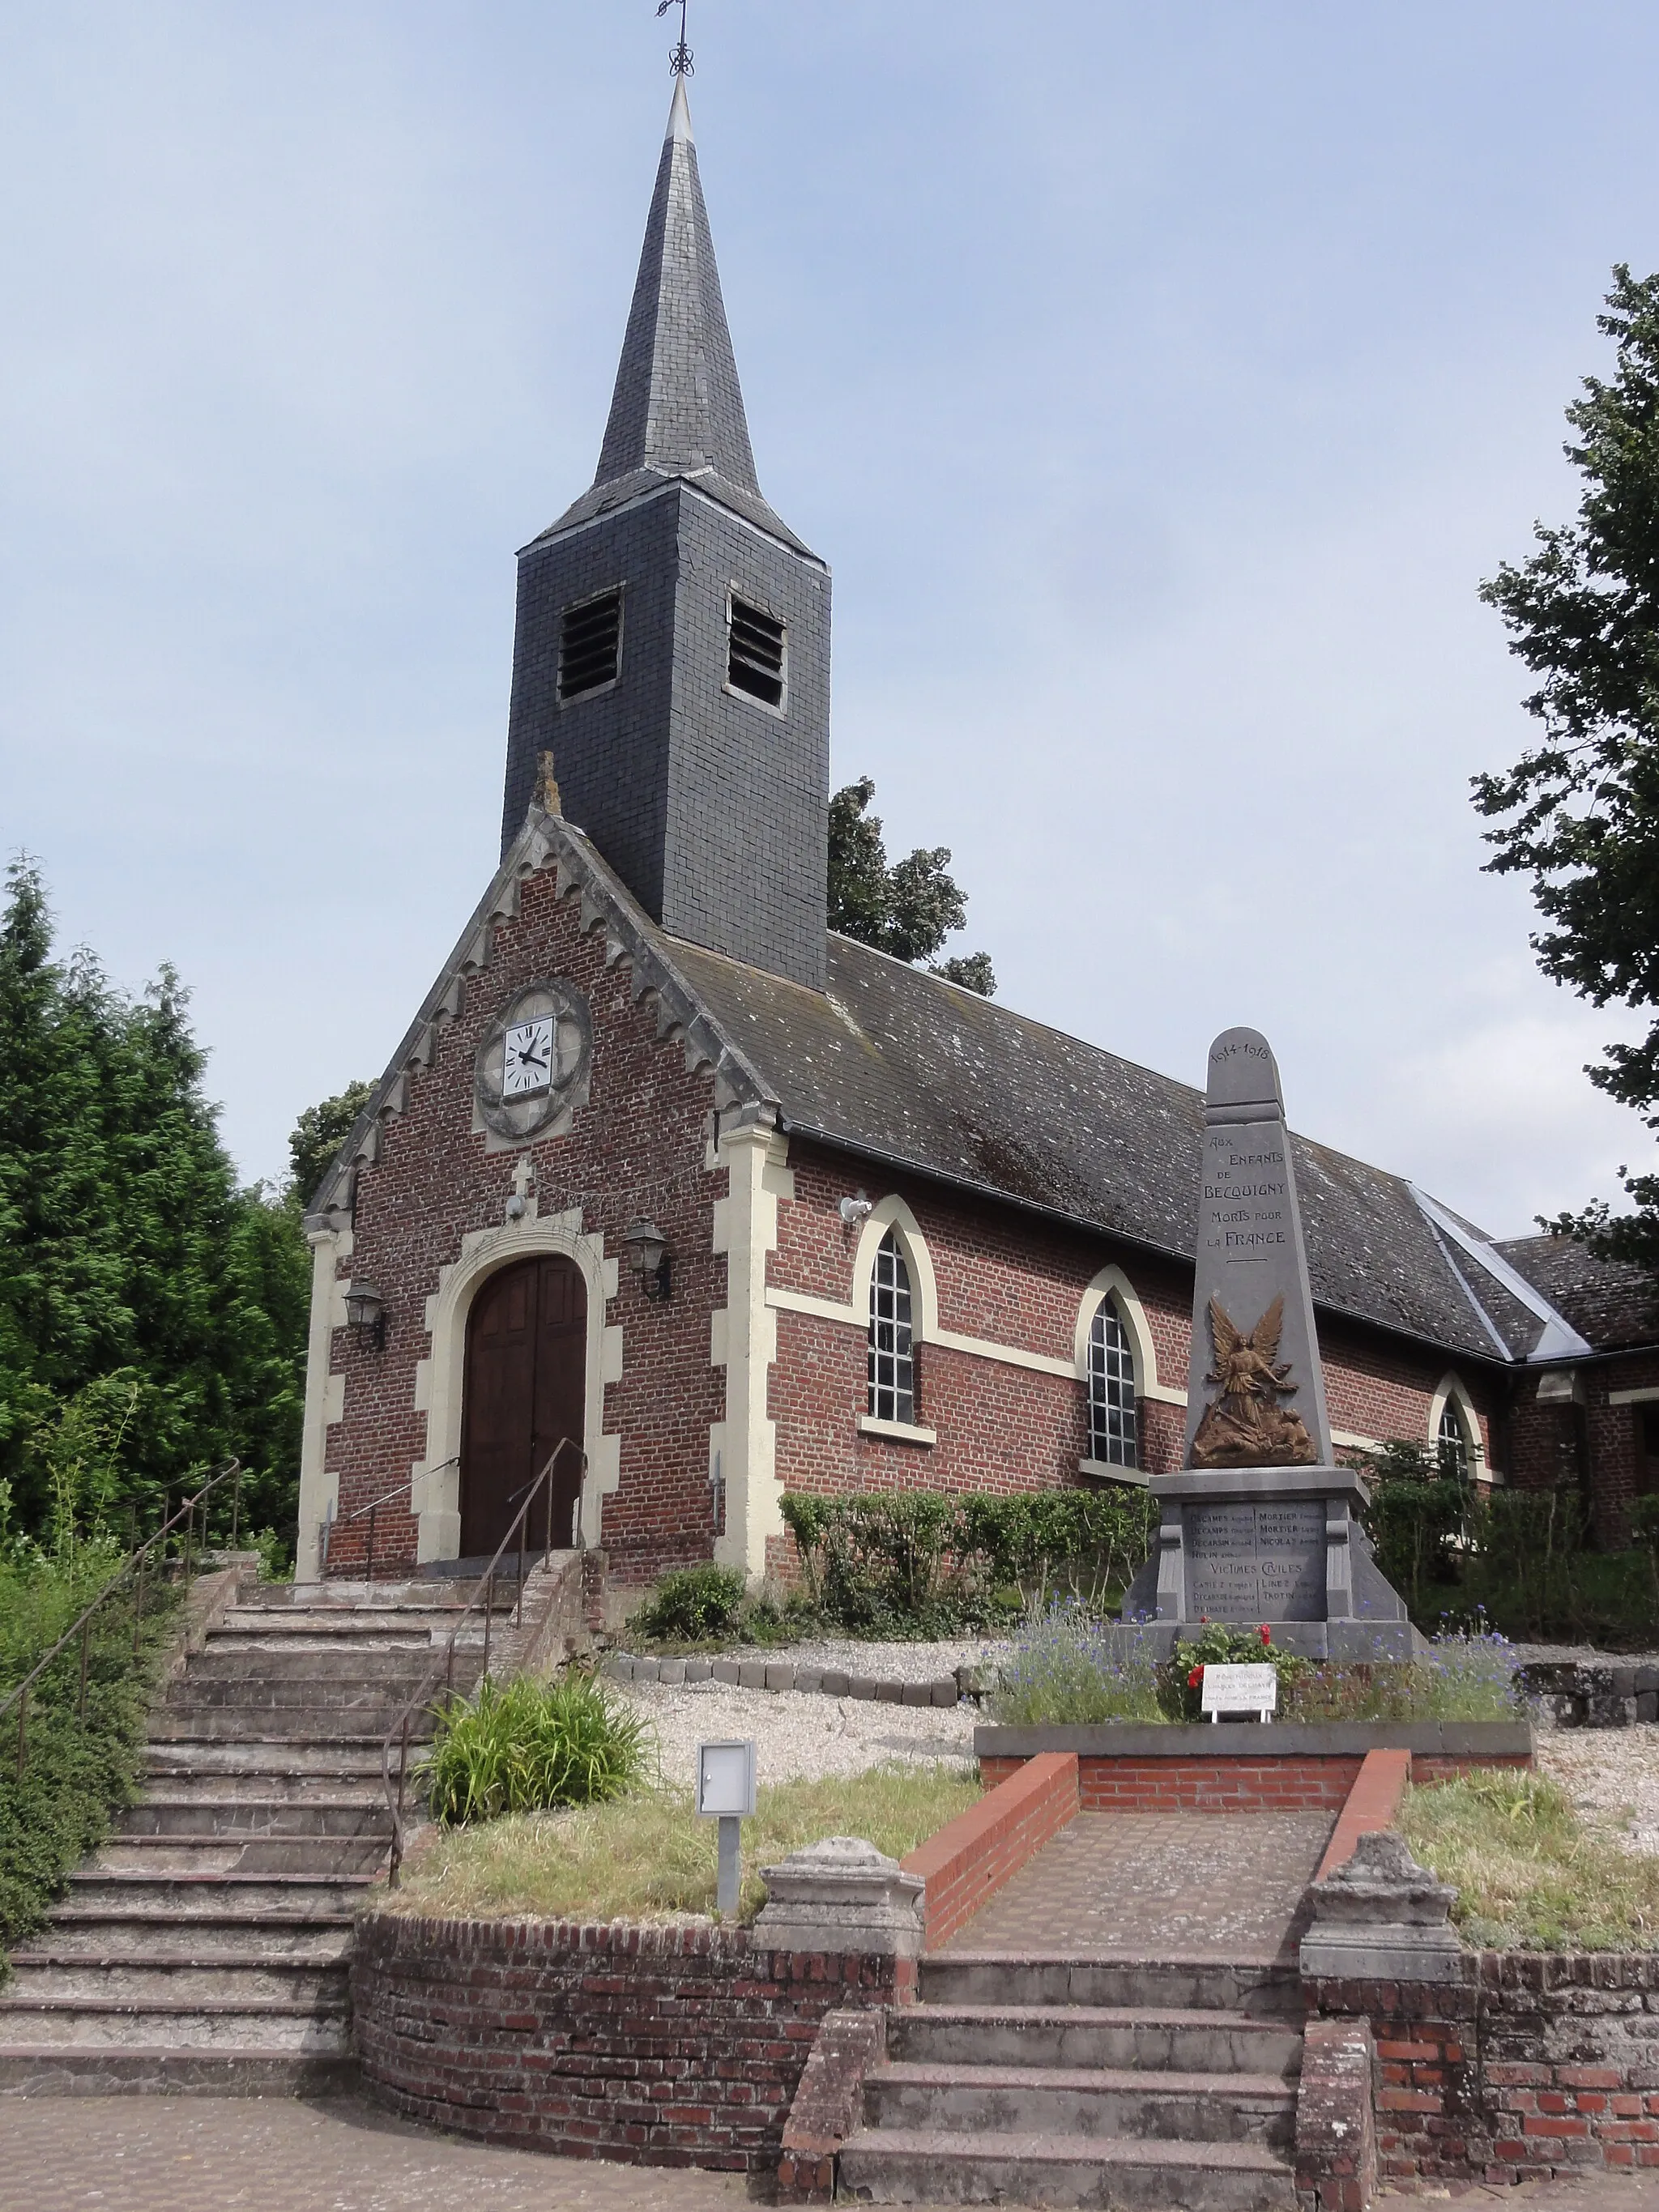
left=409, top=1210, right=621, bottom=1562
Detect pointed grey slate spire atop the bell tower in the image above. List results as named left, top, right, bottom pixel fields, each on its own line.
left=593, top=78, right=761, bottom=497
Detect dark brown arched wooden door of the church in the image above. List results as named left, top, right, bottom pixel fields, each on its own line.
left=460, top=1254, right=588, bottom=1559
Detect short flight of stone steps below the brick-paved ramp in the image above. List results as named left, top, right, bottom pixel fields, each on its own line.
left=838, top=1951, right=1303, bottom=2212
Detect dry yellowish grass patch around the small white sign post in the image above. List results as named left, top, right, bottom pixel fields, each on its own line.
left=376, top=1763, right=980, bottom=1920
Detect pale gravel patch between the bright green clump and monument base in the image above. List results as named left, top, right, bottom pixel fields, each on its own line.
left=612, top=1646, right=982, bottom=1788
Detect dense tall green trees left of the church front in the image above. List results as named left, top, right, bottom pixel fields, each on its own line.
left=0, top=860, right=309, bottom=1533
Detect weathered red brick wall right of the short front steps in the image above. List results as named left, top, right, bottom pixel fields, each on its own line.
left=1303, top=1951, right=1659, bottom=2185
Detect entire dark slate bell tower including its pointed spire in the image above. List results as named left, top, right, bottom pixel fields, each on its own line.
left=502, top=75, right=830, bottom=991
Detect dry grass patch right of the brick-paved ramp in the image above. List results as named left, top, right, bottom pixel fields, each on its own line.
left=1401, top=1767, right=1659, bottom=1951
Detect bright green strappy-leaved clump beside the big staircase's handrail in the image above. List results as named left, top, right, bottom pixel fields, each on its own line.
left=420, top=1673, right=648, bottom=1827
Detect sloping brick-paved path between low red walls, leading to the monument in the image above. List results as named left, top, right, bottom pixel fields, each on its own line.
left=945, top=1812, right=1332, bottom=1960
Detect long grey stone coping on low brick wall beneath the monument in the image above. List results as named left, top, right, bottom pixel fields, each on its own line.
left=973, top=1721, right=1533, bottom=1763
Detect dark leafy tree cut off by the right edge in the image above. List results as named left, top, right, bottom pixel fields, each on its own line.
left=1473, top=263, right=1659, bottom=1265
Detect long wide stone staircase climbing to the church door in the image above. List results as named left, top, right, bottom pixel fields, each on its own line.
left=0, top=1582, right=511, bottom=2095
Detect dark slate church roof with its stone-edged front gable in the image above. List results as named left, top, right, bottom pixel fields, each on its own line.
left=320, top=808, right=1659, bottom=1361
